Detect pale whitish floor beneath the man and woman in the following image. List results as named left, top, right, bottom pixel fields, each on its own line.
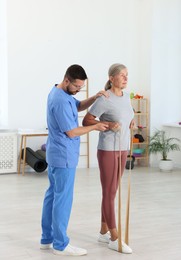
left=0, top=167, right=181, bottom=260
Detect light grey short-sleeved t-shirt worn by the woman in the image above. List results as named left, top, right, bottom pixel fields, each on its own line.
left=89, top=90, right=134, bottom=151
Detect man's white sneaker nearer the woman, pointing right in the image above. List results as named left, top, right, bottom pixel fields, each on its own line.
left=53, top=244, right=87, bottom=256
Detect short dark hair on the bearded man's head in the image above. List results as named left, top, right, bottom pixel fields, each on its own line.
left=64, top=64, right=87, bottom=81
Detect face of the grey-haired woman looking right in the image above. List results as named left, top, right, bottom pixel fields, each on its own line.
left=110, top=69, right=128, bottom=89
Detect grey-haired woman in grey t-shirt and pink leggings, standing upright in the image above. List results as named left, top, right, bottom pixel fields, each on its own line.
left=83, top=64, right=134, bottom=254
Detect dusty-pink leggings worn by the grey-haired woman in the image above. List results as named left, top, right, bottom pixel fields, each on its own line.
left=97, top=150, right=128, bottom=229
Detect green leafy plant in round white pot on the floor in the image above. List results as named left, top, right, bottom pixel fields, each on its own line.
left=148, top=129, right=180, bottom=171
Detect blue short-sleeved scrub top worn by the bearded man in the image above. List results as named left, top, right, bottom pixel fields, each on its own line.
left=46, top=86, right=80, bottom=168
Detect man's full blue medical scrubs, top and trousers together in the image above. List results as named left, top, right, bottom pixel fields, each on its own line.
left=41, top=86, right=80, bottom=250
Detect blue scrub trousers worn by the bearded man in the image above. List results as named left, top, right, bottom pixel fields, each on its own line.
left=41, top=166, right=76, bottom=251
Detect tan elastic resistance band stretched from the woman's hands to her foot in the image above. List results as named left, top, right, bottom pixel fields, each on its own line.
left=118, top=129, right=132, bottom=253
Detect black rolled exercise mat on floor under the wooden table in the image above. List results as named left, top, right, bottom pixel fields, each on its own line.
left=22, top=147, right=47, bottom=172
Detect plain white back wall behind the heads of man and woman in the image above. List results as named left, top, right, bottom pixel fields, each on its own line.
left=7, top=0, right=150, bottom=128
